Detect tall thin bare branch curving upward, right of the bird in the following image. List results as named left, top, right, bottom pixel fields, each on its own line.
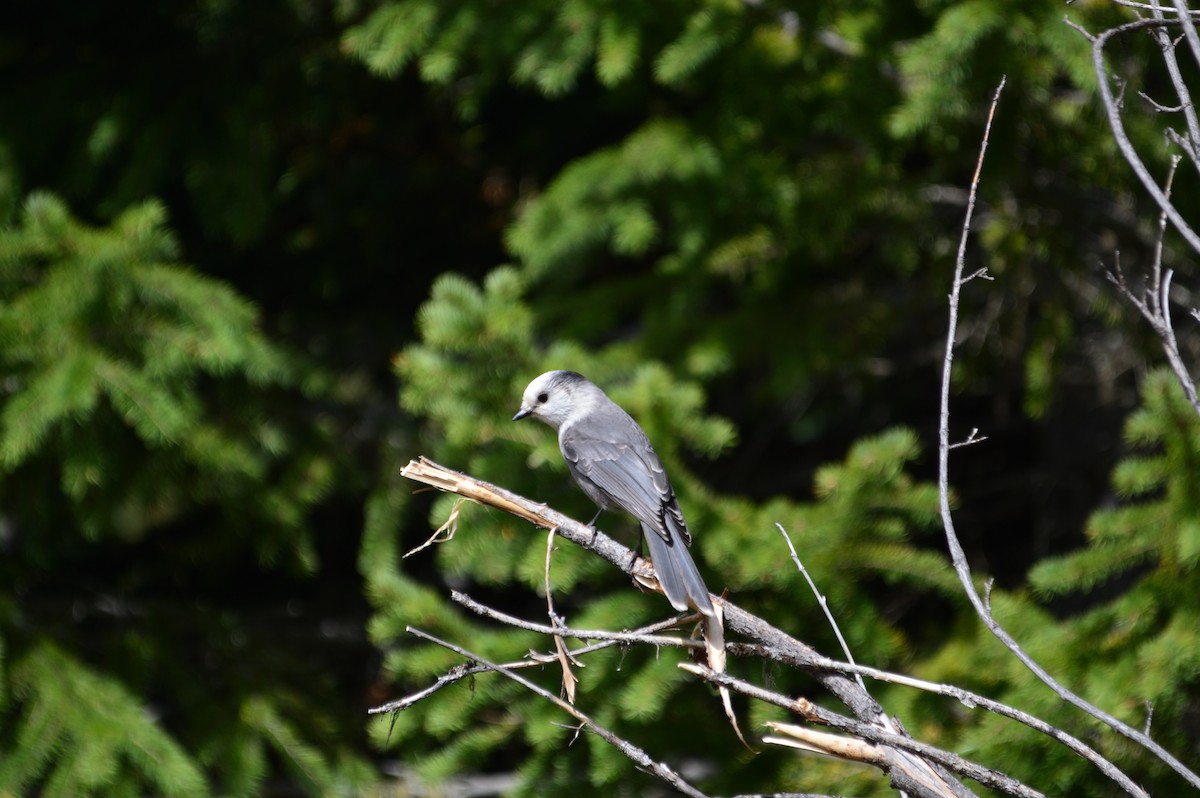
left=937, top=79, right=1200, bottom=798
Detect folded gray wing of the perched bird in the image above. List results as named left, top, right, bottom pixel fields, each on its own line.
left=558, top=408, right=691, bottom=546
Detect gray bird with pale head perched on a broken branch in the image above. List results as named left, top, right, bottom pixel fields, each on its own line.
left=512, top=371, right=713, bottom=616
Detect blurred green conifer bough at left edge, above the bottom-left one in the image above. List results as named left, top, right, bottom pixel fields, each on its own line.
left=0, top=194, right=304, bottom=554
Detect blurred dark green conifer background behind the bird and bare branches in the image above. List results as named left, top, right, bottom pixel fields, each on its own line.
left=0, top=0, right=1200, bottom=796
